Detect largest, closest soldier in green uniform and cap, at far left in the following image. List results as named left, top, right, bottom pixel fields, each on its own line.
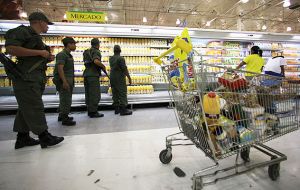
left=5, top=12, right=64, bottom=149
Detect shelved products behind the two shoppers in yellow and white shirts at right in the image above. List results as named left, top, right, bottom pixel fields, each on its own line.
left=192, top=39, right=300, bottom=80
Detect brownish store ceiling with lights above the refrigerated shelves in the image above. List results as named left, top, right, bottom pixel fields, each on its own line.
left=18, top=0, right=300, bottom=33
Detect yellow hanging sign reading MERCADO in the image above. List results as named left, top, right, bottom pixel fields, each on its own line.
left=66, top=11, right=106, bottom=22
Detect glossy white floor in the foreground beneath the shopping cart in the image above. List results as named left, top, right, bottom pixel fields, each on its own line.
left=0, top=128, right=300, bottom=190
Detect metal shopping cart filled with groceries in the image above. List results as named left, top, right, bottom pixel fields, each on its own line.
left=155, top=41, right=299, bottom=190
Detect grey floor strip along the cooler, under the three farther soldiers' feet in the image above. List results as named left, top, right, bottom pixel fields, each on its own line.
left=0, top=107, right=177, bottom=141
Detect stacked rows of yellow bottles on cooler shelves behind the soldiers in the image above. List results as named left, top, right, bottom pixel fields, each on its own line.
left=0, top=36, right=168, bottom=94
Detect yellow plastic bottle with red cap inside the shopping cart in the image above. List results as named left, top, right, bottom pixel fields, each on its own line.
left=203, top=92, right=221, bottom=119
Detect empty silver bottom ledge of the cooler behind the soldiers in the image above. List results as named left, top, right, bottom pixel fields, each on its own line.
left=0, top=91, right=171, bottom=111
